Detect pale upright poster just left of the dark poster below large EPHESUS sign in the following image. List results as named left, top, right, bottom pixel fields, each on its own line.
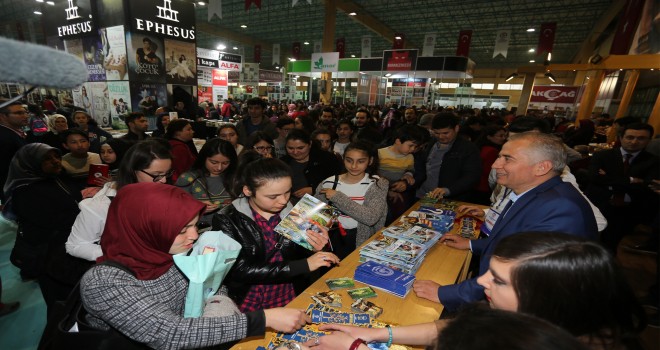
left=99, top=26, right=128, bottom=80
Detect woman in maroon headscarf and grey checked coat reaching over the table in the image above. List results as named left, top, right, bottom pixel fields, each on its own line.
left=80, top=183, right=308, bottom=349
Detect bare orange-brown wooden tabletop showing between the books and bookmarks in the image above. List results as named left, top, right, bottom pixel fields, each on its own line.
left=232, top=204, right=486, bottom=350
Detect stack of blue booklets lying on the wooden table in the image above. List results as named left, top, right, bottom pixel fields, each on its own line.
left=353, top=261, right=415, bottom=298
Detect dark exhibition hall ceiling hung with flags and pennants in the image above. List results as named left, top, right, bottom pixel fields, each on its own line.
left=0, top=0, right=625, bottom=69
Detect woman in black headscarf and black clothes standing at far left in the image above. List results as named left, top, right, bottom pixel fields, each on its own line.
left=3, top=143, right=86, bottom=309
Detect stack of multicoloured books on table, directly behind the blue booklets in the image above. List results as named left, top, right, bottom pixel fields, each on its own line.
left=360, top=236, right=428, bottom=274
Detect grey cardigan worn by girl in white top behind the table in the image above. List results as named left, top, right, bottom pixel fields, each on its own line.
left=315, top=177, right=389, bottom=247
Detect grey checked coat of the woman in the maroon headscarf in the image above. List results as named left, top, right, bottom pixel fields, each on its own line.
left=80, top=265, right=265, bottom=349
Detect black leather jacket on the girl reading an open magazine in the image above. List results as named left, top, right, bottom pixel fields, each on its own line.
left=213, top=197, right=312, bottom=305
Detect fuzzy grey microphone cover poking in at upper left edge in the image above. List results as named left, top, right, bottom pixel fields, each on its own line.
left=0, top=37, right=87, bottom=89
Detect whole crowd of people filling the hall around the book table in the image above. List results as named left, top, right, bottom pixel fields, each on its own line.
left=0, top=93, right=660, bottom=349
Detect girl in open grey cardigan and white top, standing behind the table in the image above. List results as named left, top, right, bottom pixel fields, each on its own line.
left=316, top=141, right=389, bottom=259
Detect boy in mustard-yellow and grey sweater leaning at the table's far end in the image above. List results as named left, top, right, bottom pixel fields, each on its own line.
left=378, top=125, right=423, bottom=225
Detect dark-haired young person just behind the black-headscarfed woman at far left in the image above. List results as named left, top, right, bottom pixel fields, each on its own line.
left=61, top=129, right=101, bottom=184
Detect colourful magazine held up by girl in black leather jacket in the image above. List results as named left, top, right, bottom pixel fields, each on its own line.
left=275, top=194, right=336, bottom=250
